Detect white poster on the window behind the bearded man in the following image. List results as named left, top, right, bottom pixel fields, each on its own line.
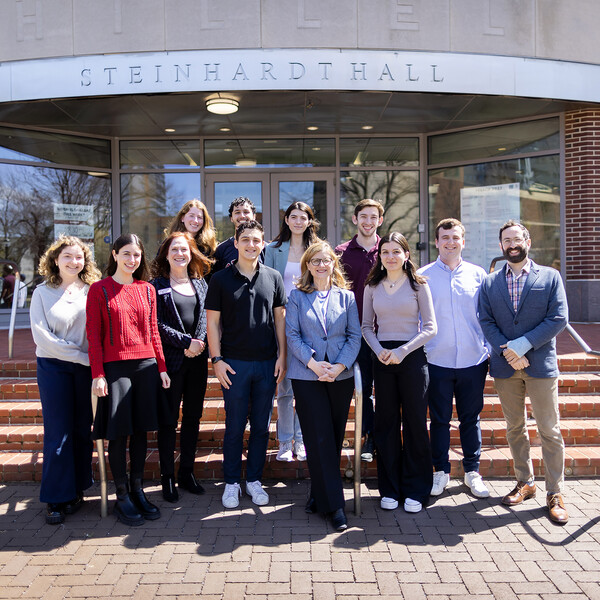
left=460, top=183, right=521, bottom=271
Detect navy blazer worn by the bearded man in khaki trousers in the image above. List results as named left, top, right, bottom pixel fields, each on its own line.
left=479, top=261, right=569, bottom=378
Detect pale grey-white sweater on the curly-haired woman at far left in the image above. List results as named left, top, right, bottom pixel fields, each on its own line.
left=29, top=283, right=90, bottom=366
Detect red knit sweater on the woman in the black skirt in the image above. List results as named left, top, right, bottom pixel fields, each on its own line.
left=86, top=277, right=167, bottom=378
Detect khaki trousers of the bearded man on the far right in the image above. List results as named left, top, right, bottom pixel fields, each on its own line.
left=494, top=370, right=565, bottom=494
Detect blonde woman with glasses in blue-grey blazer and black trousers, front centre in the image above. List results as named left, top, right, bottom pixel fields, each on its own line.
left=286, top=241, right=361, bottom=531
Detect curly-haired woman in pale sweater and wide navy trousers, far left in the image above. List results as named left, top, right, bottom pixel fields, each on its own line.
left=30, top=236, right=100, bottom=525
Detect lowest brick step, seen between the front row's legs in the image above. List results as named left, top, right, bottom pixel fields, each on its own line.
left=0, top=446, right=600, bottom=483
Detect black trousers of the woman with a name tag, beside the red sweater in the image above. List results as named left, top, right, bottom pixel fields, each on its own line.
left=158, top=348, right=208, bottom=476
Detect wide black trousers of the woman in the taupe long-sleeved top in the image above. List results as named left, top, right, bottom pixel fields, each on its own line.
left=373, top=342, right=433, bottom=504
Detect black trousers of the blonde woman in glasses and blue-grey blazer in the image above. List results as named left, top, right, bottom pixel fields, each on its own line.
left=292, top=377, right=354, bottom=513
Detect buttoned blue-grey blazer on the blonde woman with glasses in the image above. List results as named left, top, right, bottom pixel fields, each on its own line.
left=285, top=287, right=361, bottom=381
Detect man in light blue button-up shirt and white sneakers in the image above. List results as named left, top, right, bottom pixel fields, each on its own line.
left=419, top=219, right=490, bottom=498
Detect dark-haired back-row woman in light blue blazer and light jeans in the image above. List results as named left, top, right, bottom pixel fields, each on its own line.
left=265, top=202, right=319, bottom=462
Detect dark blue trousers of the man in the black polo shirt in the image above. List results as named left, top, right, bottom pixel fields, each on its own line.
left=222, top=358, right=276, bottom=483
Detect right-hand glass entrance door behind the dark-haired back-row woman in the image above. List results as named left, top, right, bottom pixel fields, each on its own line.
left=270, top=173, right=337, bottom=245
